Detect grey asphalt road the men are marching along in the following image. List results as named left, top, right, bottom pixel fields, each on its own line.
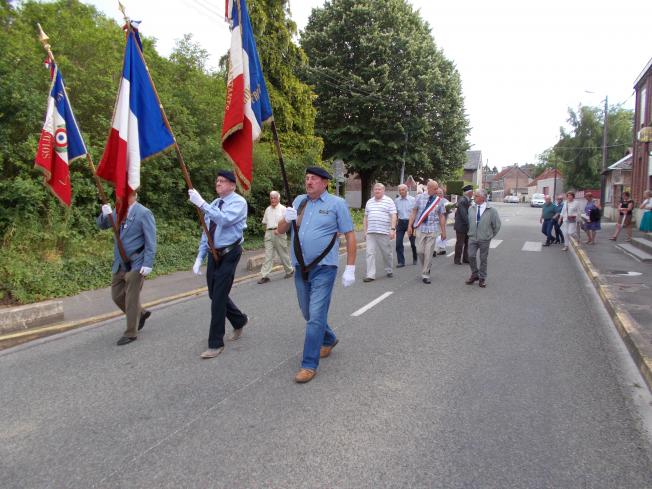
left=0, top=205, right=652, bottom=489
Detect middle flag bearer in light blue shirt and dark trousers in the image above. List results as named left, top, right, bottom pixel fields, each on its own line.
left=188, top=170, right=249, bottom=358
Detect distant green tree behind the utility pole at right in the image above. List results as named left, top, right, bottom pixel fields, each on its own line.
left=539, top=105, right=633, bottom=189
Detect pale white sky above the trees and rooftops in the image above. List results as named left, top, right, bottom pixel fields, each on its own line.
left=87, top=0, right=652, bottom=168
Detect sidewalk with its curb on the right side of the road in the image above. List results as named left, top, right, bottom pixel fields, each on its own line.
left=573, top=222, right=652, bottom=390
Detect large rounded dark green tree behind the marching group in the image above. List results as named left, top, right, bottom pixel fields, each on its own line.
left=301, top=0, right=468, bottom=201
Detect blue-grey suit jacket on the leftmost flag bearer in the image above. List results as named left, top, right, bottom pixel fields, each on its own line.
left=97, top=202, right=156, bottom=273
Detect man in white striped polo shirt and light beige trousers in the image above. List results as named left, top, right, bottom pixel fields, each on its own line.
left=362, top=183, right=396, bottom=282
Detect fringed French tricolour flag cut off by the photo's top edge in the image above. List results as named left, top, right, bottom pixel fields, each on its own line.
left=222, top=0, right=273, bottom=190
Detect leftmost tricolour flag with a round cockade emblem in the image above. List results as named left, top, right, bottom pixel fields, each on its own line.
left=34, top=58, right=87, bottom=207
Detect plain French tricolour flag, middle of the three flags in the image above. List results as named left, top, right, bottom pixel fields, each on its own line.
left=96, top=27, right=174, bottom=222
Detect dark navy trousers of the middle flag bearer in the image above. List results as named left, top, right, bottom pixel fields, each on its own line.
left=206, top=246, right=247, bottom=348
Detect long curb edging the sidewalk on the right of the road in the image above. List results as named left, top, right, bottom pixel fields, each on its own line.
left=571, top=236, right=652, bottom=391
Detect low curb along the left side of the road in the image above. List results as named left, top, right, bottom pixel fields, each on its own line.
left=0, top=242, right=366, bottom=350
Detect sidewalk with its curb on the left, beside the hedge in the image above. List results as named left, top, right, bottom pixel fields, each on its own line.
left=0, top=232, right=364, bottom=350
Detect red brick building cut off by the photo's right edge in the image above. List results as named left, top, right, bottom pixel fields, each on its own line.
left=632, top=59, right=652, bottom=221
